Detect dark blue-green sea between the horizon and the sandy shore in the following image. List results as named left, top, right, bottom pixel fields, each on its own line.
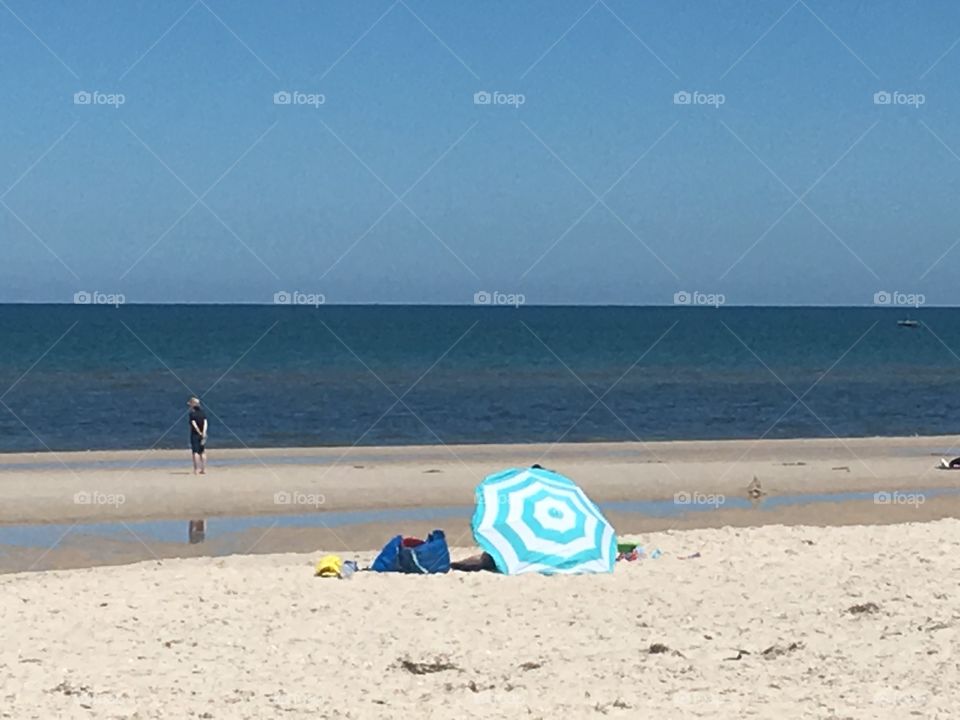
left=0, top=305, right=960, bottom=452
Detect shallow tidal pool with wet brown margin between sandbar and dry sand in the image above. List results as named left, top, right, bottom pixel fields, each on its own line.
left=0, top=490, right=960, bottom=574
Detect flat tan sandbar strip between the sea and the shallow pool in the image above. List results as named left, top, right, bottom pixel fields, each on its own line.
left=0, top=437, right=960, bottom=523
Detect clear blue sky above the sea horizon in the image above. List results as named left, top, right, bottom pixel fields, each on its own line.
left=0, top=0, right=960, bottom=305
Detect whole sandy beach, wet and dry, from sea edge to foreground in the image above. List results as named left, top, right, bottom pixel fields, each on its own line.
left=0, top=438, right=960, bottom=720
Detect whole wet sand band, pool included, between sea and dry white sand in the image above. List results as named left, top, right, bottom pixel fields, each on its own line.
left=0, top=437, right=960, bottom=572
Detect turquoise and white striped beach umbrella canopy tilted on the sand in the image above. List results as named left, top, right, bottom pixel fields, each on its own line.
left=473, top=468, right=617, bottom=575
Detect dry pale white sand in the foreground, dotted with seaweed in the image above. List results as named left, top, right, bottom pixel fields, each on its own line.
left=0, top=520, right=960, bottom=720
